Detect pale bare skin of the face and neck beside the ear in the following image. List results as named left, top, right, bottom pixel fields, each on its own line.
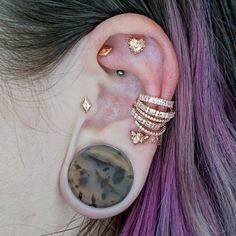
left=0, top=37, right=90, bottom=236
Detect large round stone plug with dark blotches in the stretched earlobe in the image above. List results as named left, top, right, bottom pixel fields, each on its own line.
left=68, top=144, right=133, bottom=208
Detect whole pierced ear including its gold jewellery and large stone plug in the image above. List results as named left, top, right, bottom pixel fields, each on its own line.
left=60, top=14, right=178, bottom=218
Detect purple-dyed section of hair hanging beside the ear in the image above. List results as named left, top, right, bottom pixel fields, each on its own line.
left=121, top=0, right=236, bottom=236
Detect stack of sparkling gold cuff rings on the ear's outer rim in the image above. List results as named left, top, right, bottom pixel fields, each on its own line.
left=130, top=94, right=175, bottom=145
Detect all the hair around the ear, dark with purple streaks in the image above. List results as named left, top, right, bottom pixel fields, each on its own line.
left=0, top=0, right=236, bottom=236
